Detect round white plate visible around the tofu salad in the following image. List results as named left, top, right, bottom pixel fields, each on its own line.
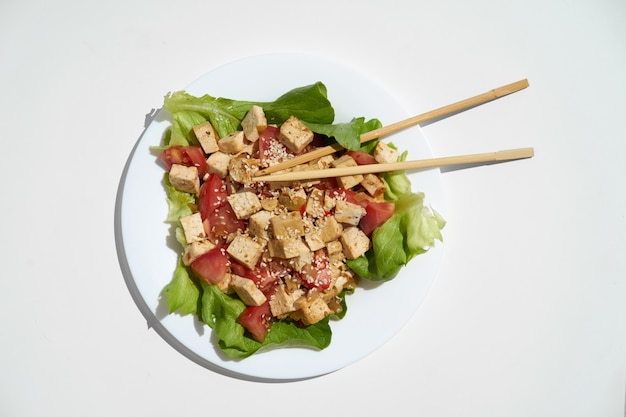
left=115, top=54, right=445, bottom=381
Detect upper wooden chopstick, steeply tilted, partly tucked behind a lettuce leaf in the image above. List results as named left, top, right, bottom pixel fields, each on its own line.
left=256, top=79, right=528, bottom=176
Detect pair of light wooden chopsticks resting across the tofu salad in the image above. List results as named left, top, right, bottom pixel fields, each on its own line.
left=253, top=79, right=534, bottom=182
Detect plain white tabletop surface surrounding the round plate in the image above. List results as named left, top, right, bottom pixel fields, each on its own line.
left=0, top=0, right=626, bottom=417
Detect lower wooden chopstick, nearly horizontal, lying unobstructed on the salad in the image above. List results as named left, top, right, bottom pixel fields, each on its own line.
left=253, top=148, right=535, bottom=182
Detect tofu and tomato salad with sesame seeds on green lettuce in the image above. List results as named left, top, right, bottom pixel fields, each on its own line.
left=153, top=82, right=445, bottom=358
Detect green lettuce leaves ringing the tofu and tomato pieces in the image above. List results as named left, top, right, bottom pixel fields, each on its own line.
left=154, top=82, right=445, bottom=358
